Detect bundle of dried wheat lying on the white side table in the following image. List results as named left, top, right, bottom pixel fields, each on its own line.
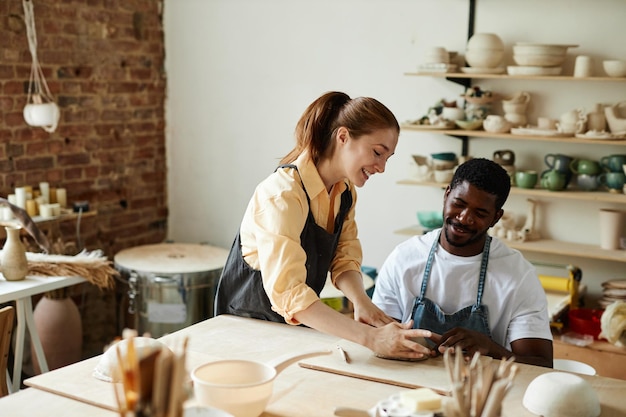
left=26, top=250, right=119, bottom=289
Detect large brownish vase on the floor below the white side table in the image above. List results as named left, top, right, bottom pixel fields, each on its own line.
left=31, top=294, right=83, bottom=374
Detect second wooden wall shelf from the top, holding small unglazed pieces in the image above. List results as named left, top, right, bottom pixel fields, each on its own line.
left=401, top=123, right=626, bottom=146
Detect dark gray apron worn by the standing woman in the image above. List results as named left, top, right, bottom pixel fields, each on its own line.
left=215, top=165, right=352, bottom=323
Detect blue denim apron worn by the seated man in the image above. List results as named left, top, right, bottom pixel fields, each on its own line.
left=413, top=230, right=491, bottom=342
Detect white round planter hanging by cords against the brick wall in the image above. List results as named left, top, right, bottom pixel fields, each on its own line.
left=22, top=0, right=61, bottom=133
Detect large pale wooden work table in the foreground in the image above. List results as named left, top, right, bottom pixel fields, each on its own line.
left=7, top=316, right=626, bottom=417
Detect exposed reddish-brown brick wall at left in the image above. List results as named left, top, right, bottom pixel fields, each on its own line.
left=0, top=0, right=168, bottom=357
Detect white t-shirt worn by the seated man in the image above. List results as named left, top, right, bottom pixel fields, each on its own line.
left=372, top=230, right=552, bottom=349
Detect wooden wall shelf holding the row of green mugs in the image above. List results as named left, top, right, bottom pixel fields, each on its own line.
left=397, top=179, right=626, bottom=204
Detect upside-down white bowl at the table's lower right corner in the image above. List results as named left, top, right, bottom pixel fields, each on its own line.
left=522, top=372, right=601, bottom=417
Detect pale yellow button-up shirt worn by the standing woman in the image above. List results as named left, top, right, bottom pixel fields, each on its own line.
left=240, top=152, right=363, bottom=324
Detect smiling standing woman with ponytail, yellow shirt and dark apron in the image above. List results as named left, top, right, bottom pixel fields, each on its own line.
left=215, top=92, right=430, bottom=359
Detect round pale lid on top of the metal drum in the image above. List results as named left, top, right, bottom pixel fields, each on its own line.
left=114, top=243, right=228, bottom=274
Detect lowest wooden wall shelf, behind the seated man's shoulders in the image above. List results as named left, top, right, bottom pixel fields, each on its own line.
left=394, top=225, right=626, bottom=263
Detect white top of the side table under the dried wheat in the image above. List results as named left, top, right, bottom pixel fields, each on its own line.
left=0, top=275, right=86, bottom=303
